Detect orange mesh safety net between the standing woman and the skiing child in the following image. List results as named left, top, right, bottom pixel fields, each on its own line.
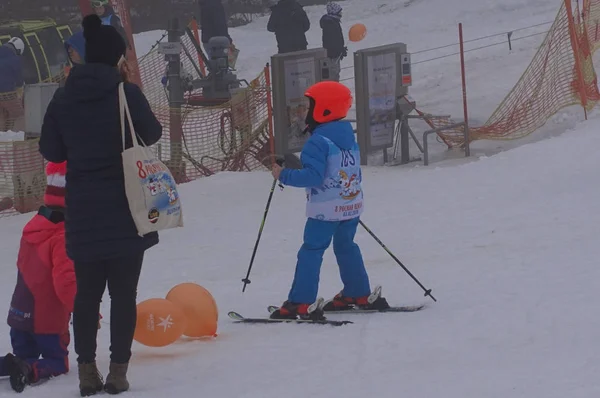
left=139, top=29, right=272, bottom=182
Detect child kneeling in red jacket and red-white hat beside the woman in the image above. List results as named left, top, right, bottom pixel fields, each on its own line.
left=0, top=162, right=77, bottom=392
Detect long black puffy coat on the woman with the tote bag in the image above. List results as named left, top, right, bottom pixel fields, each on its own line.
left=40, top=64, right=162, bottom=262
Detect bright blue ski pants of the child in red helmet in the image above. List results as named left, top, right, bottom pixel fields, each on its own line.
left=288, top=217, right=371, bottom=304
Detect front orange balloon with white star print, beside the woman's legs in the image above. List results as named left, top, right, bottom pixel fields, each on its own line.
left=133, top=298, right=187, bottom=347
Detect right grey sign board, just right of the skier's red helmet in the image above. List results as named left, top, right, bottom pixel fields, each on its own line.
left=354, top=43, right=412, bottom=164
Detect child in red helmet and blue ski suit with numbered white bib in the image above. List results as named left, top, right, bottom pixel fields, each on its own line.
left=271, top=81, right=389, bottom=319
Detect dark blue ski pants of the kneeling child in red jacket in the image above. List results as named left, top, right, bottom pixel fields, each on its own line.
left=0, top=329, right=71, bottom=381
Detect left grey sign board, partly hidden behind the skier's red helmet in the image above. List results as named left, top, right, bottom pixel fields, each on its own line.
left=271, top=48, right=327, bottom=155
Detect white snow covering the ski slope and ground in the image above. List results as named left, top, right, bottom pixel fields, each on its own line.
left=0, top=0, right=600, bottom=398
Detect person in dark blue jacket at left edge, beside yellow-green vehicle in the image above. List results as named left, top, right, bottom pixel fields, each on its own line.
left=0, top=37, right=25, bottom=131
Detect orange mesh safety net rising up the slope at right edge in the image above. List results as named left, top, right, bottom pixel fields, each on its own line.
left=435, top=0, right=600, bottom=147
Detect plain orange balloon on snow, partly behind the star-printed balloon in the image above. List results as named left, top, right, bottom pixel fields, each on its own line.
left=167, top=282, right=219, bottom=337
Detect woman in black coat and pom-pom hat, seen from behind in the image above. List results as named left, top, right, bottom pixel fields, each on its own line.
left=39, top=15, right=162, bottom=396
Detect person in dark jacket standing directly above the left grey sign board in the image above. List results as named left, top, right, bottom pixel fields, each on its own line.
left=267, top=0, right=310, bottom=54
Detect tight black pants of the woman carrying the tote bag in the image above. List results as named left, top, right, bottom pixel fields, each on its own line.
left=73, top=252, right=144, bottom=364
